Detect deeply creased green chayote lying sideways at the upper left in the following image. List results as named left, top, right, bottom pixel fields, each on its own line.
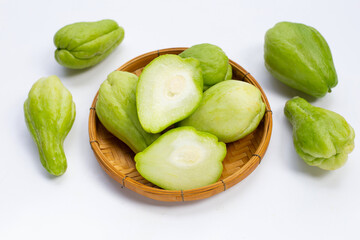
left=54, top=19, right=124, bottom=69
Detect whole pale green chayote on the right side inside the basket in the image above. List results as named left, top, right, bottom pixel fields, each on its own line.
left=179, top=80, right=265, bottom=143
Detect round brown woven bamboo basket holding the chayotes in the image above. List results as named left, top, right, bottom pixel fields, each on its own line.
left=89, top=48, right=272, bottom=202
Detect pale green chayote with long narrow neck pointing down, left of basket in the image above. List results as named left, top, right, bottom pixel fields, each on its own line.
left=24, top=75, right=75, bottom=176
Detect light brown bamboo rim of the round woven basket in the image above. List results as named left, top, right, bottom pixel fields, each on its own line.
left=88, top=47, right=272, bottom=201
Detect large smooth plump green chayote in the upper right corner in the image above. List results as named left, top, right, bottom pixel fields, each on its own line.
left=264, top=22, right=338, bottom=97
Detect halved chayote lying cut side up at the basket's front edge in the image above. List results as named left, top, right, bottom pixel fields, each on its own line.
left=135, top=127, right=226, bottom=190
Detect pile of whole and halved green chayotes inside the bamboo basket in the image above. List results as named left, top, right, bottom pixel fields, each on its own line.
left=96, top=44, right=265, bottom=190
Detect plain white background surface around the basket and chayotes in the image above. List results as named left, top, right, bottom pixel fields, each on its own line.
left=0, top=0, right=360, bottom=240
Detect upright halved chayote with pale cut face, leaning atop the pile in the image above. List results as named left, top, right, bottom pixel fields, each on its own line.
left=136, top=54, right=203, bottom=133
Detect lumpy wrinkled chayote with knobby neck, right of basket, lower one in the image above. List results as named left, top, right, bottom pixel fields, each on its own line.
left=284, top=97, right=355, bottom=170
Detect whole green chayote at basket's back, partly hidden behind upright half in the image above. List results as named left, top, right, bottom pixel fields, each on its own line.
left=179, top=43, right=229, bottom=86
